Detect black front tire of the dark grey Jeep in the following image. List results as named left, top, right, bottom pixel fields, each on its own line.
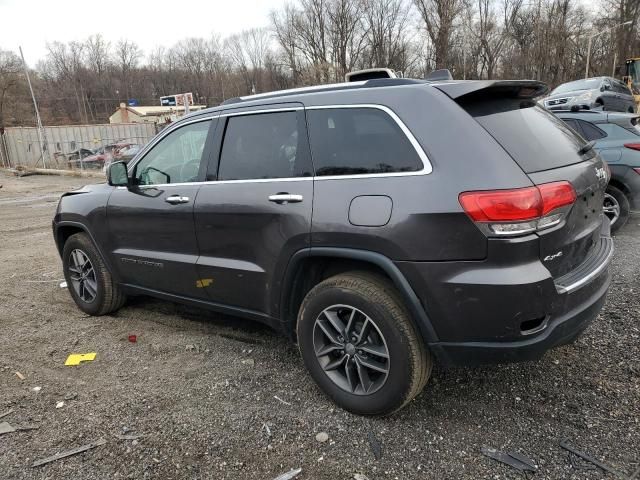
left=62, top=233, right=126, bottom=316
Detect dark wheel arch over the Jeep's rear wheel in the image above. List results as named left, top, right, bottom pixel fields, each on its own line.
left=279, top=247, right=438, bottom=344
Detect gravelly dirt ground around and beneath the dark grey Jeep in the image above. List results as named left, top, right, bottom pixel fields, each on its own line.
left=0, top=173, right=640, bottom=480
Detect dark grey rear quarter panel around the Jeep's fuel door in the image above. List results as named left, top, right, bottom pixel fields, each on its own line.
left=306, top=85, right=531, bottom=261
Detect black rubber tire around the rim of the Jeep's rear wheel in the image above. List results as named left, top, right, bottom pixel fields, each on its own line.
left=297, top=272, right=432, bottom=415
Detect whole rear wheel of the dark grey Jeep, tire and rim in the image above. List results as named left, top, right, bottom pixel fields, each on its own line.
left=297, top=272, right=432, bottom=415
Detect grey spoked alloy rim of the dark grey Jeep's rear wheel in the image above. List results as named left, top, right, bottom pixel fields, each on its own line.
left=313, top=305, right=390, bottom=395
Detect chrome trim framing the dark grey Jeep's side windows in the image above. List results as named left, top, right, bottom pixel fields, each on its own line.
left=128, top=102, right=433, bottom=189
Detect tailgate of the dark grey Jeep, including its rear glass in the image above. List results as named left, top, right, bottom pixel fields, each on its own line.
left=462, top=98, right=608, bottom=277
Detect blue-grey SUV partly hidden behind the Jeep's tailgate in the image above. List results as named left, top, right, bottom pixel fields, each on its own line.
left=558, top=112, right=640, bottom=232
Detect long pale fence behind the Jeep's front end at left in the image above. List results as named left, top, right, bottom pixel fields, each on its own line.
left=0, top=123, right=157, bottom=170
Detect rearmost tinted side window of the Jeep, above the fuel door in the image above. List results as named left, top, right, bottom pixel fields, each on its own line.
left=307, top=108, right=422, bottom=176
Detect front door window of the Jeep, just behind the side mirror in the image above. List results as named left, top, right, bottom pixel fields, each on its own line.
left=134, top=120, right=211, bottom=185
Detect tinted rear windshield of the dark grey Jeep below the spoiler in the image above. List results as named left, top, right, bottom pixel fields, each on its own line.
left=461, top=99, right=586, bottom=173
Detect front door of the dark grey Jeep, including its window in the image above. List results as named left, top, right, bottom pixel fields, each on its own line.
left=107, top=119, right=216, bottom=298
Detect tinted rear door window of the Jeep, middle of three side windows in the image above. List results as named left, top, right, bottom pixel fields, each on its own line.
left=218, top=111, right=312, bottom=180
